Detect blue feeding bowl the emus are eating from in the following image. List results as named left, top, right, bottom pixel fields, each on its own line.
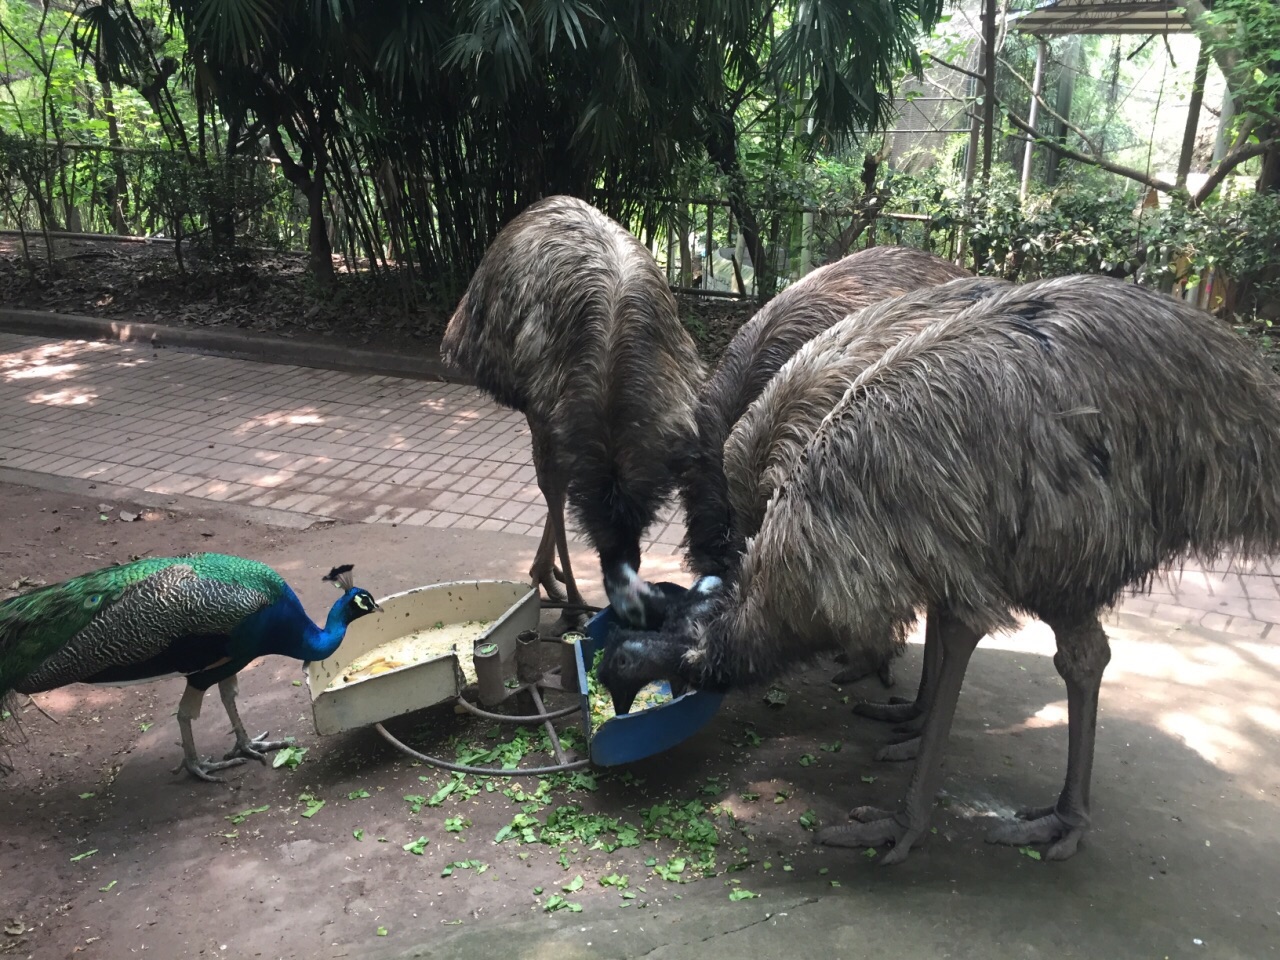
left=576, top=584, right=724, bottom=767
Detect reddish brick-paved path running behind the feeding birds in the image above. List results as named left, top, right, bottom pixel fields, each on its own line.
left=0, top=333, right=1280, bottom=637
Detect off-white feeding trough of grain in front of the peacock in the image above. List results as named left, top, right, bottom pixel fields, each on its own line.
left=306, top=580, right=539, bottom=735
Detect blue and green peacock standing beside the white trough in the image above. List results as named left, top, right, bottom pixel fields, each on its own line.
left=0, top=553, right=381, bottom=782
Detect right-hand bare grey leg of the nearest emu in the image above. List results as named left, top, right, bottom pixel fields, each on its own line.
left=987, top=616, right=1111, bottom=860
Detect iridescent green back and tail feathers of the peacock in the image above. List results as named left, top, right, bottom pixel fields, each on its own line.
left=0, top=553, right=284, bottom=699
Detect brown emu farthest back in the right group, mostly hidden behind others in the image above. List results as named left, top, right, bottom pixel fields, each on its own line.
left=680, top=247, right=969, bottom=577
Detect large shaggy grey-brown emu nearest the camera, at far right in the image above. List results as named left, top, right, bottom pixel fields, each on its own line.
left=600, top=276, right=1280, bottom=863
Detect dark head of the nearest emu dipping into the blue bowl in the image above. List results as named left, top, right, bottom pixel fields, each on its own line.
left=596, top=577, right=722, bottom=714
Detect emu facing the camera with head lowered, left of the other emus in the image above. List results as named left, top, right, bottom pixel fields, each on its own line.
left=440, top=197, right=704, bottom=626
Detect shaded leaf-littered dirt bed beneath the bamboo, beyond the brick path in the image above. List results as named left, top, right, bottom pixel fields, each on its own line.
left=0, top=234, right=755, bottom=361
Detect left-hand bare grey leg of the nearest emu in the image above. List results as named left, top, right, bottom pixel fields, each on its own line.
left=818, top=616, right=982, bottom=864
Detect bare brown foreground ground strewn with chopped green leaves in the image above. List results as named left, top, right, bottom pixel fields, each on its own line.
left=0, top=486, right=1280, bottom=960
